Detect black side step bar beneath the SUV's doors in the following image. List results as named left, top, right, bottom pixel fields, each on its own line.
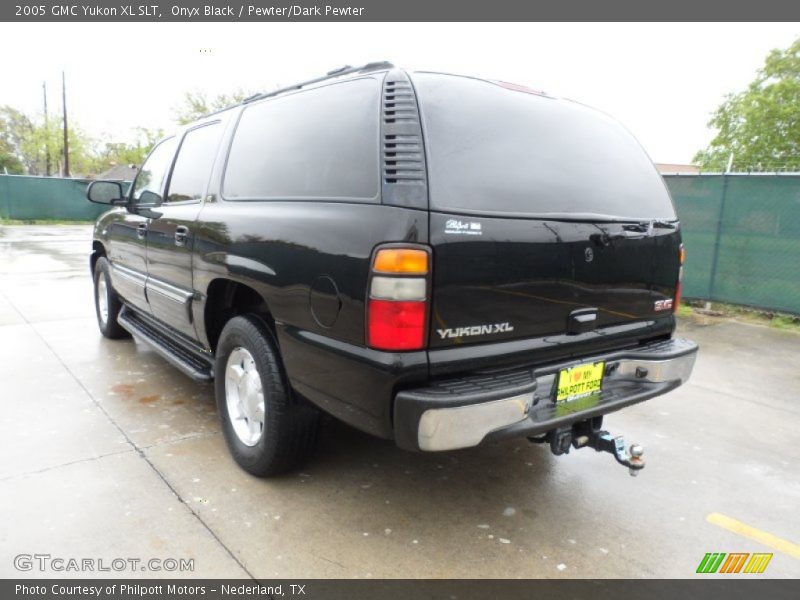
left=117, top=305, right=214, bottom=381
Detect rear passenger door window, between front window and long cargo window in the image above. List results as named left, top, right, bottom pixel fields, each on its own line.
left=167, top=123, right=222, bottom=202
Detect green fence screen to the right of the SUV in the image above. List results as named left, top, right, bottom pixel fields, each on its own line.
left=664, top=174, right=800, bottom=314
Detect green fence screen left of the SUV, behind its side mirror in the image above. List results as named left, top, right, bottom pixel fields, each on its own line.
left=0, top=175, right=108, bottom=221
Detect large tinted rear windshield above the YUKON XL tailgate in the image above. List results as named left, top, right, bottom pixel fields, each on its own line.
left=413, top=73, right=675, bottom=219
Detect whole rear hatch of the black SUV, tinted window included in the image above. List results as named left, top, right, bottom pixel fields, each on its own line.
left=412, top=73, right=680, bottom=354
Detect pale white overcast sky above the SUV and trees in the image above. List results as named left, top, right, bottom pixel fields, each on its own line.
left=0, top=23, right=800, bottom=163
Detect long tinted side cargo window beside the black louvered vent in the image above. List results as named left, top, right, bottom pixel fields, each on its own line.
left=223, top=78, right=380, bottom=201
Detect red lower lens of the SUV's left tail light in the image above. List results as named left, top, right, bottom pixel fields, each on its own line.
left=367, top=299, right=427, bottom=350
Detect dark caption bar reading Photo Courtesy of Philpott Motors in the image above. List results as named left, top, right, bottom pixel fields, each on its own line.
left=0, top=576, right=800, bottom=600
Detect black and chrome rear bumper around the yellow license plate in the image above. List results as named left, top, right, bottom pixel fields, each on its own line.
left=394, top=339, right=698, bottom=451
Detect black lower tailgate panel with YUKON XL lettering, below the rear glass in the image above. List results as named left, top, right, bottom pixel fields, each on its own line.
left=429, top=213, right=680, bottom=348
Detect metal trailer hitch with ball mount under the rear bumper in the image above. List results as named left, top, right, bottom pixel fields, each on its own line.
left=528, top=417, right=644, bottom=477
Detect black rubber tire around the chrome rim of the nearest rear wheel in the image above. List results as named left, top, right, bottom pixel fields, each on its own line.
left=219, top=315, right=319, bottom=477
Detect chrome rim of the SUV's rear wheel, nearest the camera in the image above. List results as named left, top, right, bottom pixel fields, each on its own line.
left=225, top=347, right=264, bottom=446
